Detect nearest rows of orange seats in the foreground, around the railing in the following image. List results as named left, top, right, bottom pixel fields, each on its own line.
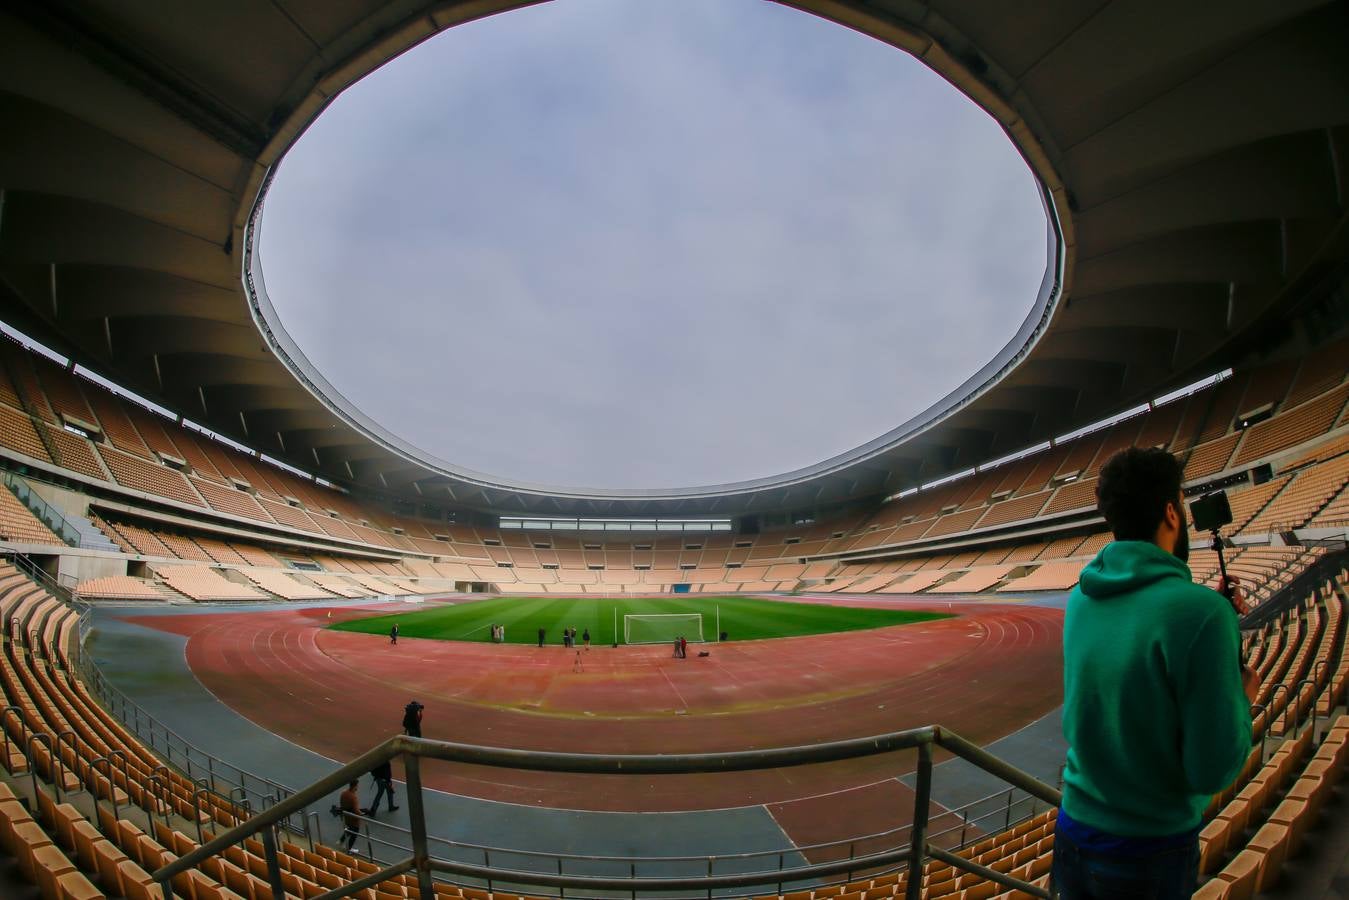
left=0, top=555, right=1349, bottom=900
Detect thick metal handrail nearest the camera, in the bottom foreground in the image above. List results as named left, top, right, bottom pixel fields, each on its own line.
left=152, top=726, right=1060, bottom=900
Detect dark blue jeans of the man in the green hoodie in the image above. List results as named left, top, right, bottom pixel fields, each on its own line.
left=1054, top=833, right=1199, bottom=900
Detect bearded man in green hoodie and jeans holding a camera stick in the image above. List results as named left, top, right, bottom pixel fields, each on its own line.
left=1054, top=448, right=1259, bottom=900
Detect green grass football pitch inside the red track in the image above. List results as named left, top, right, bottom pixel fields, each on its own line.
left=331, top=595, right=950, bottom=646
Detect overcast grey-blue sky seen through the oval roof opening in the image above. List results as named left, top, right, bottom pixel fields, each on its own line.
left=262, top=0, right=1045, bottom=487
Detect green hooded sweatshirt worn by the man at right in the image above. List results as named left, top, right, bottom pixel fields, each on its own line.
left=1063, top=541, right=1252, bottom=837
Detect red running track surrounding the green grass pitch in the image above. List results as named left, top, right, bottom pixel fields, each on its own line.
left=127, top=598, right=1063, bottom=843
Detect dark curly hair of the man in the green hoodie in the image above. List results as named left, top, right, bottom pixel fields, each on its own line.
left=1097, top=447, right=1184, bottom=541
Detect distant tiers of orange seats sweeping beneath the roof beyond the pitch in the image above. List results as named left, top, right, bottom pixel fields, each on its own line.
left=0, top=341, right=1349, bottom=612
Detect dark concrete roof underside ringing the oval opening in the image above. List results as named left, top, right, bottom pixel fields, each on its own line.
left=0, top=0, right=1349, bottom=517
